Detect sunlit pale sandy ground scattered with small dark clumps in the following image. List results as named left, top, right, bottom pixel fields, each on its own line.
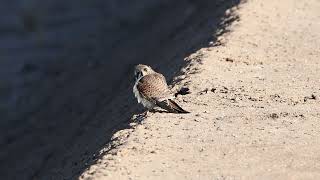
left=80, top=0, right=320, bottom=179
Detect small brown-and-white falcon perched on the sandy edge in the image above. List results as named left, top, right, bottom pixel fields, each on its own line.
left=133, top=64, right=189, bottom=113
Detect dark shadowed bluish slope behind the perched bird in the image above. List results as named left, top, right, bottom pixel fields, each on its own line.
left=0, top=0, right=239, bottom=180
